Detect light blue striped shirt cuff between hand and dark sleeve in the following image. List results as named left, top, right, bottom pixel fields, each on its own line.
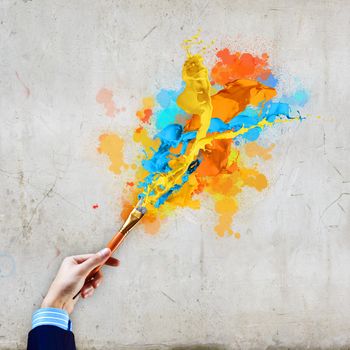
left=32, top=307, right=72, bottom=331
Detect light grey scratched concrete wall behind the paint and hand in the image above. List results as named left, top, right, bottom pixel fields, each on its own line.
left=0, top=0, right=350, bottom=350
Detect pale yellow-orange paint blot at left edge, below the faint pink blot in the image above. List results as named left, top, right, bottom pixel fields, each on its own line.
left=97, top=133, right=128, bottom=174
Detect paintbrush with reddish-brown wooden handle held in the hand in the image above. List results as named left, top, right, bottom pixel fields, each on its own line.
left=73, top=199, right=146, bottom=299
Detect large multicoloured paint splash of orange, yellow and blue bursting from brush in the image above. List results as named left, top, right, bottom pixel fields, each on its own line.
left=99, top=36, right=308, bottom=238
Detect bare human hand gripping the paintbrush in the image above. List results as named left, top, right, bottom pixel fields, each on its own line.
left=41, top=248, right=119, bottom=314
